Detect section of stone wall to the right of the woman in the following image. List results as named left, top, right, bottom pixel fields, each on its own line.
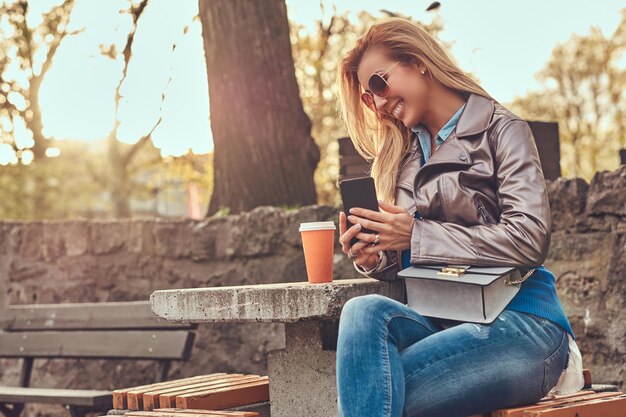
left=546, top=165, right=626, bottom=390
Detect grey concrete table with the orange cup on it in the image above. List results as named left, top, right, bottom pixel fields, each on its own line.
left=150, top=278, right=404, bottom=417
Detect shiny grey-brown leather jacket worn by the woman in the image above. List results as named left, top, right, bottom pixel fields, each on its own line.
left=364, top=93, right=551, bottom=281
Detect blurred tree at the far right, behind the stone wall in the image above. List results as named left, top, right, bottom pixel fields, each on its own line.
left=511, top=9, right=626, bottom=180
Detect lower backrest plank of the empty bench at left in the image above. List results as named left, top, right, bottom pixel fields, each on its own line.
left=0, top=330, right=194, bottom=360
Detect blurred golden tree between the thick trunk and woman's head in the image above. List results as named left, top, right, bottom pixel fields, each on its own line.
left=291, top=6, right=448, bottom=206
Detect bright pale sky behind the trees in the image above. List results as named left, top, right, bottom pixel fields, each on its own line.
left=2, top=0, right=626, bottom=161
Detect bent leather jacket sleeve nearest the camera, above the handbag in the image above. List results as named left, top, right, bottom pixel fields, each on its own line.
left=411, top=119, right=552, bottom=267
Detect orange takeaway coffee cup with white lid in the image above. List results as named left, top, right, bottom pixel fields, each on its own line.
left=299, top=221, right=337, bottom=284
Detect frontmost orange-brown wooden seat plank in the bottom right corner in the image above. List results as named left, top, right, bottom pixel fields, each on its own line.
left=523, top=393, right=626, bottom=417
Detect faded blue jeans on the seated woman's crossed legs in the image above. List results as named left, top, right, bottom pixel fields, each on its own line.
left=337, top=294, right=569, bottom=417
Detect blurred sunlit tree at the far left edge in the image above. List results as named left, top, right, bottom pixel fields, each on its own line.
left=0, top=0, right=80, bottom=218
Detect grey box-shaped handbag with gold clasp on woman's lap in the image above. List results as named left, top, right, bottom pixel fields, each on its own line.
left=398, top=265, right=535, bottom=323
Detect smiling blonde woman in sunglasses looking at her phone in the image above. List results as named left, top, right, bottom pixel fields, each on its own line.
left=337, top=18, right=582, bottom=417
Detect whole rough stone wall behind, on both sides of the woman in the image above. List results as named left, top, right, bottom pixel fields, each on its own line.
left=0, top=166, right=626, bottom=415
